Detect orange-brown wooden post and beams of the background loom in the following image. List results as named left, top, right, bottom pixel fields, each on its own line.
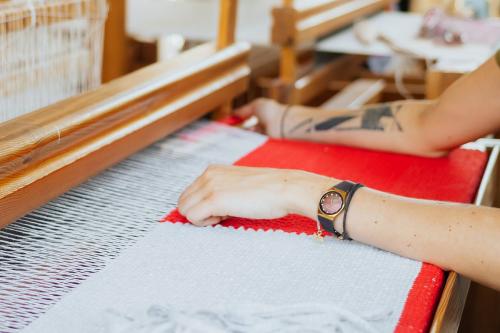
left=268, top=0, right=394, bottom=104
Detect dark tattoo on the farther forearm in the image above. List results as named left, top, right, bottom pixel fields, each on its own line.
left=314, top=104, right=403, bottom=132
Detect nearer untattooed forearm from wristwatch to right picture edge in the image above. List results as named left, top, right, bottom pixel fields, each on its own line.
left=294, top=178, right=500, bottom=290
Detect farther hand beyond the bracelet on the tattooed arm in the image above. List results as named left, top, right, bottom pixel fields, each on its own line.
left=235, top=98, right=285, bottom=138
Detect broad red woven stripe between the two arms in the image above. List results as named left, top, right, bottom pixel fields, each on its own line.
left=236, top=140, right=487, bottom=202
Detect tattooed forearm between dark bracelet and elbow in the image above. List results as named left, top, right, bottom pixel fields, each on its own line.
left=281, top=101, right=442, bottom=156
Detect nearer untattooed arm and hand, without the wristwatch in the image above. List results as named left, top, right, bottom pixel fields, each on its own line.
left=179, top=166, right=500, bottom=290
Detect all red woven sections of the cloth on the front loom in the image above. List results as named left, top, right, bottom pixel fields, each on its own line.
left=164, top=139, right=487, bottom=332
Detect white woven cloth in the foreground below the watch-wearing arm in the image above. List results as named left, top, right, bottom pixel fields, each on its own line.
left=26, top=223, right=421, bottom=333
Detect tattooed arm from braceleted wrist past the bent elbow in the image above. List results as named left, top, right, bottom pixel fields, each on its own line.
left=267, top=52, right=500, bottom=156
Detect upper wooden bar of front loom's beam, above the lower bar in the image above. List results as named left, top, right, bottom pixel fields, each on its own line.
left=0, top=44, right=248, bottom=180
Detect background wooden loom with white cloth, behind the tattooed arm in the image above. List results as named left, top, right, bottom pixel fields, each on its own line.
left=270, top=0, right=495, bottom=104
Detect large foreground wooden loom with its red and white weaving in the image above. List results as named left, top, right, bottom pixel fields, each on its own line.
left=0, top=0, right=499, bottom=332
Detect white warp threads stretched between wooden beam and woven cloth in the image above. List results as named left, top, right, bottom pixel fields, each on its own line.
left=0, top=121, right=266, bottom=333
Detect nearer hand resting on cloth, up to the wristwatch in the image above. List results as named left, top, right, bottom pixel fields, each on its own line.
left=179, top=165, right=336, bottom=226
